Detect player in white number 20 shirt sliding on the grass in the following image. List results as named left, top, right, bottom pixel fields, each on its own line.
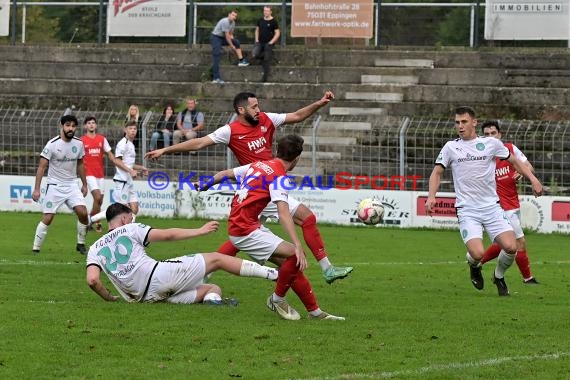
left=86, top=203, right=278, bottom=306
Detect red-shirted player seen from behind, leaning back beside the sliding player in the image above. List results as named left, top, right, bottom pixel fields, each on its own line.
left=199, top=135, right=344, bottom=320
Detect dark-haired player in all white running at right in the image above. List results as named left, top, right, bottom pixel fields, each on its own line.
left=425, top=106, right=543, bottom=296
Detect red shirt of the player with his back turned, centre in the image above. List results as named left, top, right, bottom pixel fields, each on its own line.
left=228, top=159, right=292, bottom=236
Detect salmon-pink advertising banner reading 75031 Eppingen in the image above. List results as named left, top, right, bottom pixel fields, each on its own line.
left=291, top=0, right=374, bottom=38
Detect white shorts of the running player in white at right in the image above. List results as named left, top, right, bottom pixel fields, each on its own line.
left=457, top=203, right=513, bottom=243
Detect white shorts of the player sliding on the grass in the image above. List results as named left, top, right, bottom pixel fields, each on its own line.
left=144, top=254, right=206, bottom=303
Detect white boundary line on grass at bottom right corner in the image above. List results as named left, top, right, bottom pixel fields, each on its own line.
left=298, top=352, right=570, bottom=380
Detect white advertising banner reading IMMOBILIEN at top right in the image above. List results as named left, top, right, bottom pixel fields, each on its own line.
left=485, top=0, right=570, bottom=40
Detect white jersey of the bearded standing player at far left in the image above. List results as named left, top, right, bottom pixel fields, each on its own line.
left=40, top=136, right=85, bottom=186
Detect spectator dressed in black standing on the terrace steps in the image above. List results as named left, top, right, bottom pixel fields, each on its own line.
left=251, top=6, right=281, bottom=82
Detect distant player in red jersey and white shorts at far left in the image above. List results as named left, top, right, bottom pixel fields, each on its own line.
left=81, top=116, right=115, bottom=232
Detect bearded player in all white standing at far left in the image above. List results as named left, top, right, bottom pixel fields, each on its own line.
left=32, top=115, right=88, bottom=254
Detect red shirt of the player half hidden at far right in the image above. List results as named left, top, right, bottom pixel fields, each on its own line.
left=495, top=143, right=527, bottom=211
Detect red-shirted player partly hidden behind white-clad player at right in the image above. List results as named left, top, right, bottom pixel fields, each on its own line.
left=481, top=120, right=538, bottom=284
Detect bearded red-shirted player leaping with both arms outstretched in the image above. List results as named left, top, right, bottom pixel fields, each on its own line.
left=145, top=91, right=352, bottom=284
